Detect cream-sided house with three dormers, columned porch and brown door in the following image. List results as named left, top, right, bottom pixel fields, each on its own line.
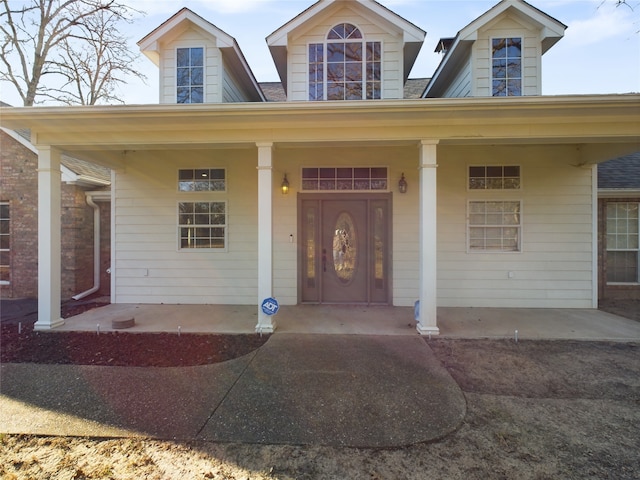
left=0, top=0, right=640, bottom=334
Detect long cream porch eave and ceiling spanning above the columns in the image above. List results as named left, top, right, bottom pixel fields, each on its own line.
left=0, top=95, right=640, bottom=168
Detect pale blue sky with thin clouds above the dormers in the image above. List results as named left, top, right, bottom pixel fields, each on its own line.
left=0, top=0, right=640, bottom=105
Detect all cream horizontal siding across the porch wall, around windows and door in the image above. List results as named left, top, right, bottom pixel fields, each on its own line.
left=113, top=146, right=595, bottom=308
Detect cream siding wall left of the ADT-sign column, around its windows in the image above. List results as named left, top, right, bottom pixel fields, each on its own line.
left=114, top=149, right=257, bottom=304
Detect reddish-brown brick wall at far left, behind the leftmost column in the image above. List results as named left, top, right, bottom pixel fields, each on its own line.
left=0, top=131, right=110, bottom=300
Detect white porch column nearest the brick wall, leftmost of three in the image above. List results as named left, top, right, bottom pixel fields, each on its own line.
left=34, top=146, right=64, bottom=330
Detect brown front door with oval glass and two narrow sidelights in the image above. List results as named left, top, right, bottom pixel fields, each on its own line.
left=298, top=194, right=391, bottom=304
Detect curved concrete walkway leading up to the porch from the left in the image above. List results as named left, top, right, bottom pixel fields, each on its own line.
left=0, top=334, right=466, bottom=447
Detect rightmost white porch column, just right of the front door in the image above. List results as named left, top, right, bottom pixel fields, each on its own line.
left=417, top=140, right=440, bottom=335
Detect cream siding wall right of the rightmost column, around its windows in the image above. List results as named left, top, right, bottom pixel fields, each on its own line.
left=438, top=146, right=594, bottom=308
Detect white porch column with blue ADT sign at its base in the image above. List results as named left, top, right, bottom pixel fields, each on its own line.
left=256, top=142, right=276, bottom=333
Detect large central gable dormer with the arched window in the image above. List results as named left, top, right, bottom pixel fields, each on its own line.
left=267, top=0, right=426, bottom=101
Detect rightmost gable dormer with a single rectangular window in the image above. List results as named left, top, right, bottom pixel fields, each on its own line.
left=423, top=0, right=567, bottom=98
